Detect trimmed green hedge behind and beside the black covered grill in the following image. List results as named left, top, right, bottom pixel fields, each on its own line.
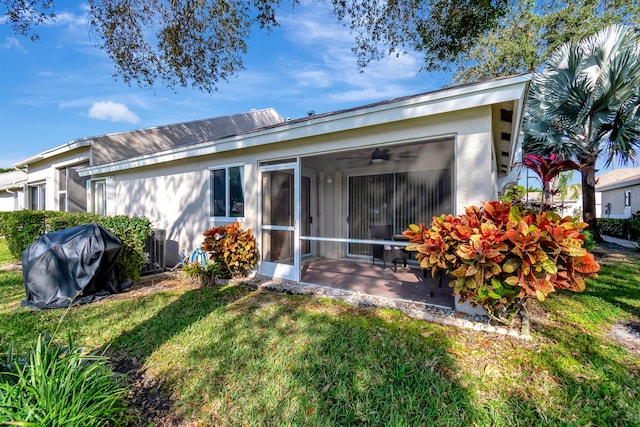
left=0, top=210, right=151, bottom=282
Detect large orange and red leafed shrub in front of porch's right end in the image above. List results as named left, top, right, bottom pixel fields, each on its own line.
left=403, top=202, right=600, bottom=318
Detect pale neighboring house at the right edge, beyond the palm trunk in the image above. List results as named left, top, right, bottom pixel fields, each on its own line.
left=596, top=168, right=640, bottom=218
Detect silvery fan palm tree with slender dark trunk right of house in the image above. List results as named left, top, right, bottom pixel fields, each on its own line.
left=523, top=25, right=640, bottom=241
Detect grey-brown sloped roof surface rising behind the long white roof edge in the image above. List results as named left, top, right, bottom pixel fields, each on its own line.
left=91, top=108, right=284, bottom=166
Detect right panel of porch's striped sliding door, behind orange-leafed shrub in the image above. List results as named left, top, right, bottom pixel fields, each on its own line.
left=393, top=168, right=453, bottom=234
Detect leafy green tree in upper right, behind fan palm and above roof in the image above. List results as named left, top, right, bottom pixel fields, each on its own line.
left=454, top=0, right=640, bottom=83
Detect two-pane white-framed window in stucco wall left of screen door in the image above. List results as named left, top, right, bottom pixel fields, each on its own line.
left=209, top=165, right=244, bottom=218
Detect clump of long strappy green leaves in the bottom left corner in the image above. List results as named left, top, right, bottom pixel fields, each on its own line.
left=0, top=336, right=129, bottom=427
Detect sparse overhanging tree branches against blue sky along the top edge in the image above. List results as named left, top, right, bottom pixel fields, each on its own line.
left=0, top=0, right=508, bottom=91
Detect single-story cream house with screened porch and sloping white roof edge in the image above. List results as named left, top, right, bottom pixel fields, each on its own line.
left=11, top=75, right=530, bottom=312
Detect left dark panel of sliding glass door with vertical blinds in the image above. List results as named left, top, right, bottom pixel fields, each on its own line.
left=349, top=174, right=394, bottom=255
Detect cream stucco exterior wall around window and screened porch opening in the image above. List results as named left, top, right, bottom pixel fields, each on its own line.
left=104, top=107, right=497, bottom=253
